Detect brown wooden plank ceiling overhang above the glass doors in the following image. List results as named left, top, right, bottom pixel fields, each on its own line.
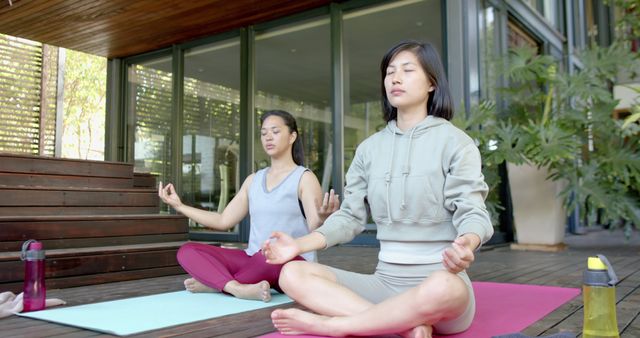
left=0, top=0, right=331, bottom=58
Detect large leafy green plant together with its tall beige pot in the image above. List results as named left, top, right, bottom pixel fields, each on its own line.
left=458, top=44, right=640, bottom=250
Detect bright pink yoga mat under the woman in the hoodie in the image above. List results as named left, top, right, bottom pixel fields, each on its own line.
left=262, top=282, right=580, bottom=338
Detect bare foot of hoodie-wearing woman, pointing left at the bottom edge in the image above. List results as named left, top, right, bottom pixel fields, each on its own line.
left=271, top=309, right=343, bottom=337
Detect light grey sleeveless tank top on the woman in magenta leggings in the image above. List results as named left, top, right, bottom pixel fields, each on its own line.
left=245, top=166, right=316, bottom=262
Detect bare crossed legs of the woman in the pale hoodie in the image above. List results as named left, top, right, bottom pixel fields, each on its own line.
left=271, top=262, right=469, bottom=337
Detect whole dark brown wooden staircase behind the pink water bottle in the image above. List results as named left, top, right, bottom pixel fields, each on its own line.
left=0, top=154, right=189, bottom=292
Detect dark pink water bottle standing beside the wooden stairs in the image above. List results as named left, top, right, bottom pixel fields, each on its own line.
left=21, top=239, right=47, bottom=312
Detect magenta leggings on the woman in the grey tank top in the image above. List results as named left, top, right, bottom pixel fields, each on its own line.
left=178, top=243, right=303, bottom=292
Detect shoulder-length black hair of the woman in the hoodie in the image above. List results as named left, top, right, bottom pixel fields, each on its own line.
left=380, top=40, right=453, bottom=122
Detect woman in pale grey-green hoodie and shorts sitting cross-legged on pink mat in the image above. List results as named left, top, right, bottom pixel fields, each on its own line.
left=263, top=41, right=493, bottom=337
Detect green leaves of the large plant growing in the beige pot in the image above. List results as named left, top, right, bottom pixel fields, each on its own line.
left=455, top=44, right=640, bottom=231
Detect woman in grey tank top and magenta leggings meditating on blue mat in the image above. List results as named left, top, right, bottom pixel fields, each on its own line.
left=158, top=110, right=339, bottom=302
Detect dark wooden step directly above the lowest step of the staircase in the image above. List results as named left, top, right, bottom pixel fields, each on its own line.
left=0, top=214, right=189, bottom=252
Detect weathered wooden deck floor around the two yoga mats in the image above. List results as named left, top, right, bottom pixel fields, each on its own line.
left=0, top=231, right=640, bottom=338
